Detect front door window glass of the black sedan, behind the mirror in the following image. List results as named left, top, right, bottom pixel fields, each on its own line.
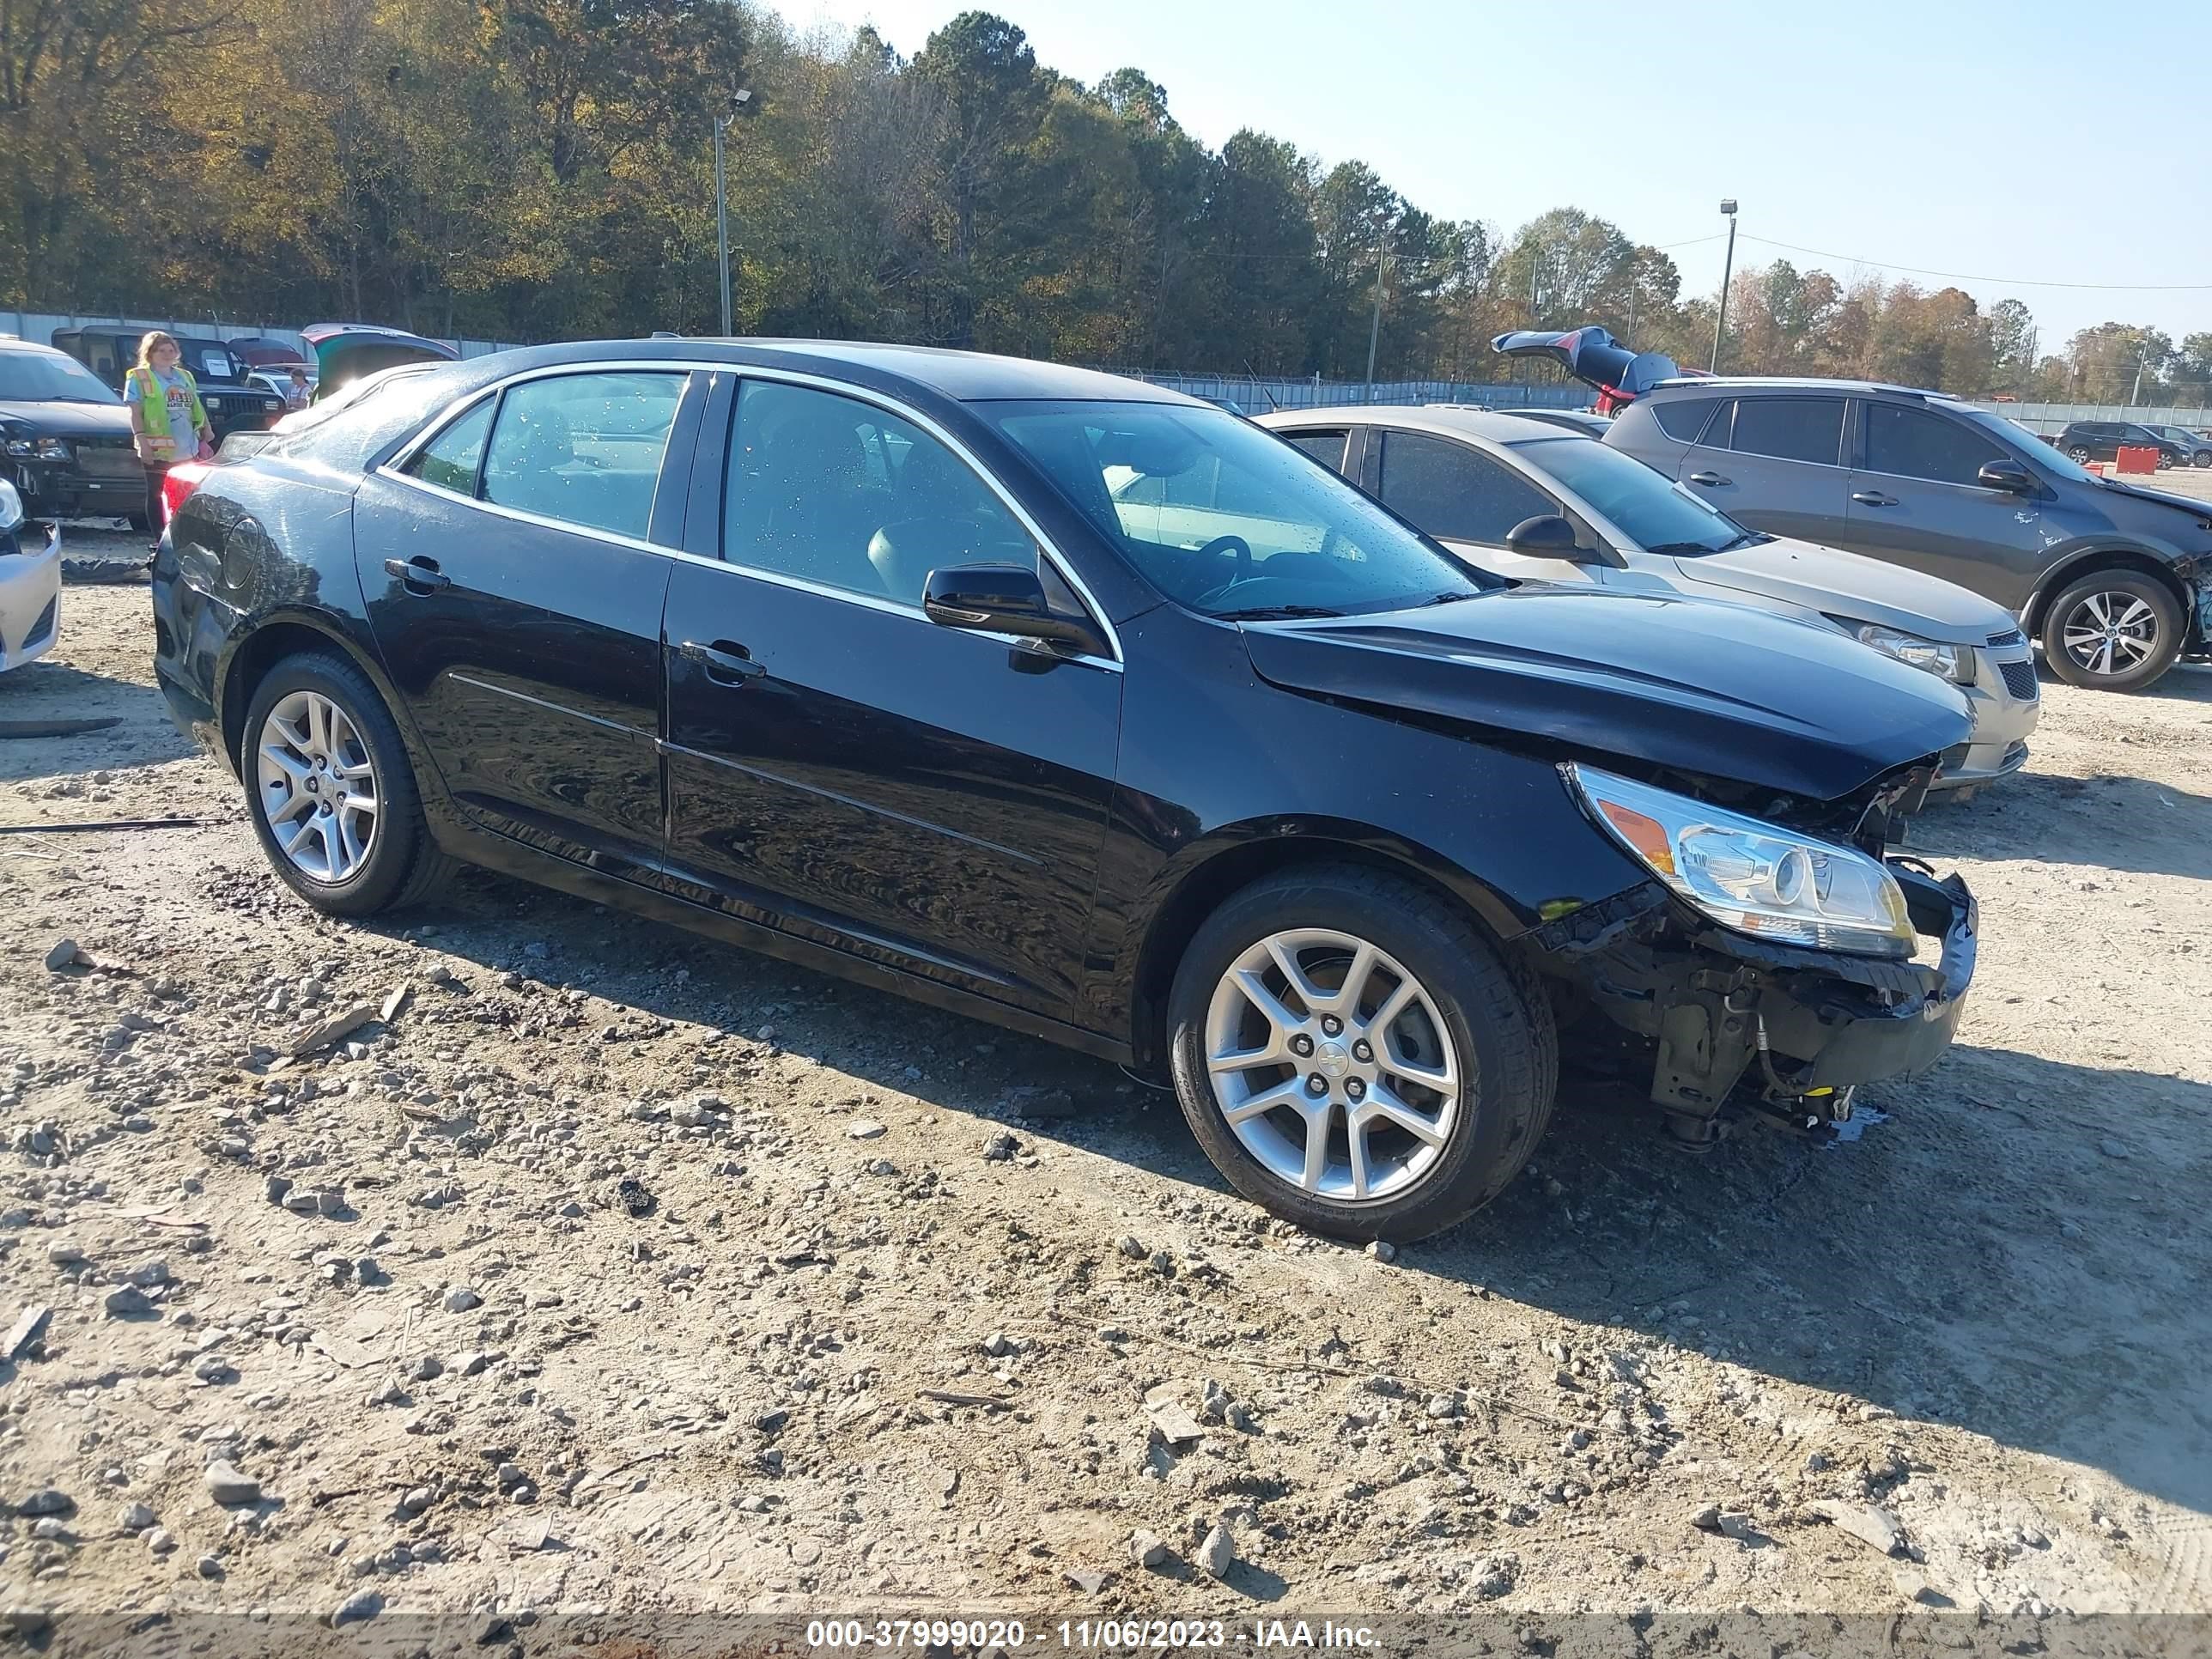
left=721, top=380, right=1037, bottom=606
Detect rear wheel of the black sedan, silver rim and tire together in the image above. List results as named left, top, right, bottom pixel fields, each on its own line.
left=239, top=653, right=452, bottom=915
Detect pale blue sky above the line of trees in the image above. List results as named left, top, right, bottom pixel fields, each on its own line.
left=781, top=0, right=2212, bottom=352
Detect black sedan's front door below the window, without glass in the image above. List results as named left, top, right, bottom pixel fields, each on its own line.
left=665, top=564, right=1121, bottom=1011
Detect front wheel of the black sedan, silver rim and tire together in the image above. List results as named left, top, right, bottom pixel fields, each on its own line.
left=1170, top=869, right=1558, bottom=1239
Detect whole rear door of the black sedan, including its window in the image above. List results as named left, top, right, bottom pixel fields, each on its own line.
left=354, top=374, right=686, bottom=865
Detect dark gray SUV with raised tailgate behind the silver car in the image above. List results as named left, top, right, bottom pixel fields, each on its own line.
left=1606, top=378, right=2212, bottom=690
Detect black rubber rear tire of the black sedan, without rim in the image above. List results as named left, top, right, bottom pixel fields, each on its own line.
left=239, top=650, right=456, bottom=915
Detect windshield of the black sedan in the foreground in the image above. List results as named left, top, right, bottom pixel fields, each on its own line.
left=988, top=403, right=1486, bottom=619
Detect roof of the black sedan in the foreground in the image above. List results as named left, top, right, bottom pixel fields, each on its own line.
left=438, top=338, right=1212, bottom=410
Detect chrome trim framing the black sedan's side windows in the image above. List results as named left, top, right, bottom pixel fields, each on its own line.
left=374, top=358, right=1126, bottom=672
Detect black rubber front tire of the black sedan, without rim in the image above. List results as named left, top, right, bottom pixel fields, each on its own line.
left=1168, top=865, right=1559, bottom=1241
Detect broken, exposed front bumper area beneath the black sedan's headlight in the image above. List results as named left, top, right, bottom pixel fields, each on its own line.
left=1535, top=858, right=1978, bottom=1119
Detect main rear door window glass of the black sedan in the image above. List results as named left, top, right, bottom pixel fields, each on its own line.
left=483, top=372, right=686, bottom=542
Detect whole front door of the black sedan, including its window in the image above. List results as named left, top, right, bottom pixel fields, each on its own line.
left=664, top=380, right=1121, bottom=1013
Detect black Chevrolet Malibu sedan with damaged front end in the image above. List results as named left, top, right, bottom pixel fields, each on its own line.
left=153, top=341, right=1975, bottom=1239
